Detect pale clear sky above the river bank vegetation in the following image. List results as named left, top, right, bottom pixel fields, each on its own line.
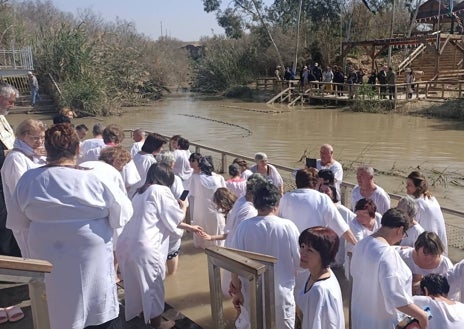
left=52, top=0, right=273, bottom=41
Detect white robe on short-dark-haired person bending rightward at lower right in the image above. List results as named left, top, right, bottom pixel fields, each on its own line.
left=351, top=236, right=412, bottom=329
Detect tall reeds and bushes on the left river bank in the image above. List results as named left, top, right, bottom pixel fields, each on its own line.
left=0, top=0, right=190, bottom=115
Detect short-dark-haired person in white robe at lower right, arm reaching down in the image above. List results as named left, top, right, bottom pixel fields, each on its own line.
left=351, top=209, right=427, bottom=329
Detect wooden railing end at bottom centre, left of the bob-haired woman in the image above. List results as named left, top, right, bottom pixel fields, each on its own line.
left=205, top=247, right=277, bottom=329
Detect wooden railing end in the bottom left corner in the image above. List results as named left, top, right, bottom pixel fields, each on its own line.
left=0, top=256, right=53, bottom=329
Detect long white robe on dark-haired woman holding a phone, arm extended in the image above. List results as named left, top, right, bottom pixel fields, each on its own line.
left=116, top=185, right=184, bottom=322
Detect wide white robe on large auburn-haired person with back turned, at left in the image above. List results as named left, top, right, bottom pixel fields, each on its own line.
left=7, top=166, right=132, bottom=329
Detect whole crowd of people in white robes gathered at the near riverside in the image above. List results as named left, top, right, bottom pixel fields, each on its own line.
left=0, top=85, right=464, bottom=329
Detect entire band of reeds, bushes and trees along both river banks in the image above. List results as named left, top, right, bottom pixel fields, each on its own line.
left=0, top=0, right=440, bottom=115
